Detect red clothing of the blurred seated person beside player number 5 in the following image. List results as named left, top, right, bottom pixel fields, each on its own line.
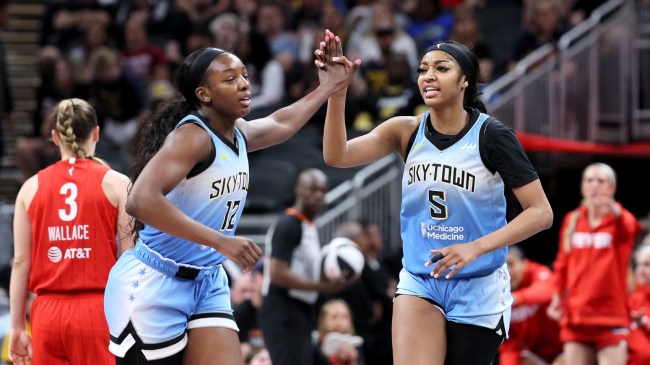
left=499, top=259, right=562, bottom=365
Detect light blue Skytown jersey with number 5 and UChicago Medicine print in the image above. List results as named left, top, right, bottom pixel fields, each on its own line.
left=401, top=112, right=507, bottom=278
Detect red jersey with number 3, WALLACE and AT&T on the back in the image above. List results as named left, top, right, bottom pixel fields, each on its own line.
left=27, top=159, right=118, bottom=294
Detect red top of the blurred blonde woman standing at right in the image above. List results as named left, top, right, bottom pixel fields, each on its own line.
left=554, top=203, right=641, bottom=328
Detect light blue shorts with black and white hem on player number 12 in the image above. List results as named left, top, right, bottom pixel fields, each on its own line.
left=104, top=243, right=239, bottom=360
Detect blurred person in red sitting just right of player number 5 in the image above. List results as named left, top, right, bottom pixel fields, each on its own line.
left=499, top=245, right=563, bottom=365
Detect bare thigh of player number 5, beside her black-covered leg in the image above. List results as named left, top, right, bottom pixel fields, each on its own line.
left=393, top=295, right=447, bottom=365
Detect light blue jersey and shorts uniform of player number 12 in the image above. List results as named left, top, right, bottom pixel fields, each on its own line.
left=104, top=115, right=248, bottom=361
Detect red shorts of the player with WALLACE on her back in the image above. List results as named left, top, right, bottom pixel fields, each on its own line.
left=30, top=293, right=115, bottom=365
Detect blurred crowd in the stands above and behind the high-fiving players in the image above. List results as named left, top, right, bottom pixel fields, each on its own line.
left=2, top=0, right=604, bottom=179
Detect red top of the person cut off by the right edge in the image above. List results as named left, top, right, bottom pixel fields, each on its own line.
left=627, top=285, right=650, bottom=365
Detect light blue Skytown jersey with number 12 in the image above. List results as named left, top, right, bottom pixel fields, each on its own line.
left=139, top=115, right=249, bottom=267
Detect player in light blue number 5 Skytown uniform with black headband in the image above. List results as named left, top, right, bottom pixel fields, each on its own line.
left=316, top=37, right=553, bottom=365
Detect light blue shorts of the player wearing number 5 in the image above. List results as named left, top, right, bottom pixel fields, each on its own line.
left=397, top=264, right=512, bottom=336
